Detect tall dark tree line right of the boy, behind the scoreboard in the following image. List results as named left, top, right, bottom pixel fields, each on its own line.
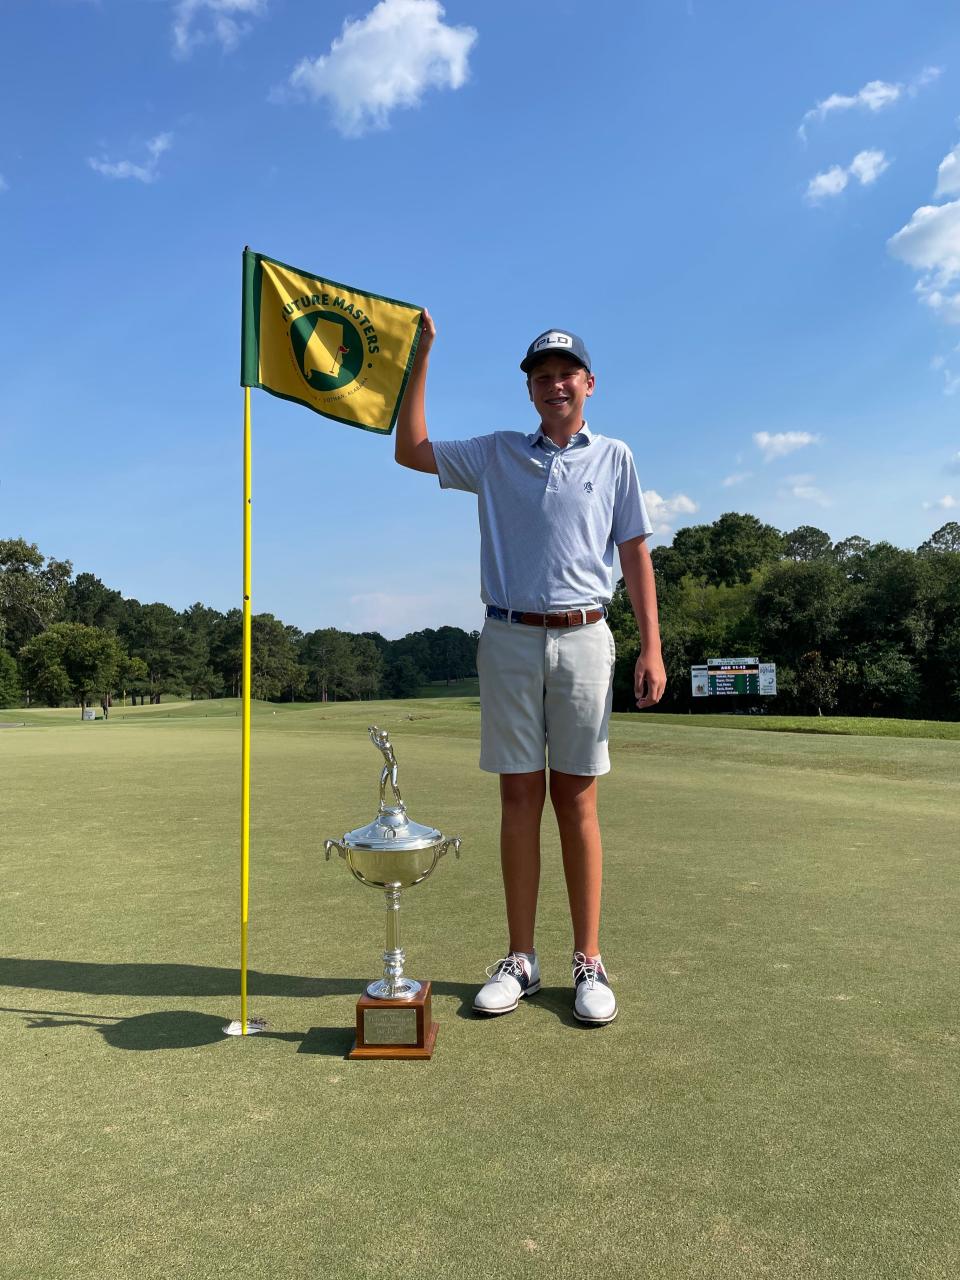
left=611, top=512, right=960, bottom=719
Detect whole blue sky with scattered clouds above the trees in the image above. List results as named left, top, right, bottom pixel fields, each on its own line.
left=0, top=0, right=960, bottom=636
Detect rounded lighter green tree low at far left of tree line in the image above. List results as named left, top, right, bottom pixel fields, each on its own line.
left=20, top=622, right=124, bottom=714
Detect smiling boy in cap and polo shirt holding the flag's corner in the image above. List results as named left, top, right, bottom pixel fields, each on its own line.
left=396, top=311, right=667, bottom=1025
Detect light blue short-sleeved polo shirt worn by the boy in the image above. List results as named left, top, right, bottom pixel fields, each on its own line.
left=433, top=422, right=653, bottom=613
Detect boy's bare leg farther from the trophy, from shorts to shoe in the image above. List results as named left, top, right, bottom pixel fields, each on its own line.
left=550, top=769, right=603, bottom=956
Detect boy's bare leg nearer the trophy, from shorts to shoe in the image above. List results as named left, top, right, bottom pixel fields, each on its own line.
left=500, top=769, right=547, bottom=951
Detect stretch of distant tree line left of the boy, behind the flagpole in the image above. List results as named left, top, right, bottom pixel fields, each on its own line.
left=0, top=539, right=479, bottom=707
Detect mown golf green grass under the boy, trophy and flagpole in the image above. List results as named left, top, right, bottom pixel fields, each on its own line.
left=0, top=698, right=960, bottom=1280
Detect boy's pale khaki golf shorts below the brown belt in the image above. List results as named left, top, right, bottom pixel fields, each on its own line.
left=476, top=618, right=614, bottom=777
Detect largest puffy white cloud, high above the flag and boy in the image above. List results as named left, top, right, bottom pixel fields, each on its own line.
left=288, top=0, right=476, bottom=138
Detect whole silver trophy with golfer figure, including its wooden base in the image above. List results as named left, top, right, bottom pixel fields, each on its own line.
left=324, top=724, right=460, bottom=1059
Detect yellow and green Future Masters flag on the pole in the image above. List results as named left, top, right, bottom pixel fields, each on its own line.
left=241, top=250, right=424, bottom=435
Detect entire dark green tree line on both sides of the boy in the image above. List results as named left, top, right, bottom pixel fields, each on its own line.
left=0, top=512, right=960, bottom=719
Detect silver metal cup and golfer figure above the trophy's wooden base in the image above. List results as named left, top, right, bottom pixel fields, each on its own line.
left=324, top=724, right=460, bottom=1029
